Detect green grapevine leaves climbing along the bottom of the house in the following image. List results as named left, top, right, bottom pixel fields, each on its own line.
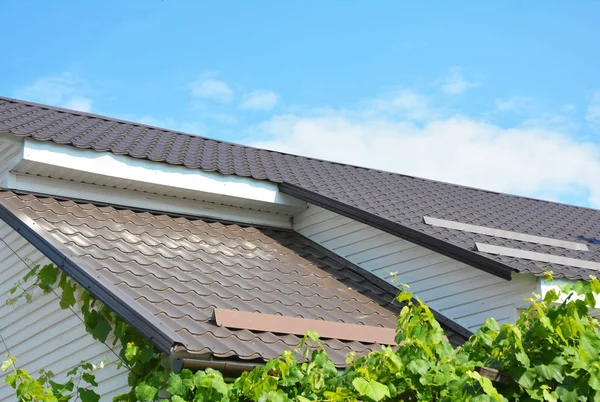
left=5, top=267, right=600, bottom=402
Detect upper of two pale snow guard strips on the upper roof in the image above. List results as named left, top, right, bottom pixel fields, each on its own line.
left=423, top=216, right=588, bottom=251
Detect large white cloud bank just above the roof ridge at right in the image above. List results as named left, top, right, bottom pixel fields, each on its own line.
left=253, top=93, right=600, bottom=207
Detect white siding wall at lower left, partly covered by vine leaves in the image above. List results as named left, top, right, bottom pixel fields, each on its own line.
left=0, top=221, right=129, bottom=402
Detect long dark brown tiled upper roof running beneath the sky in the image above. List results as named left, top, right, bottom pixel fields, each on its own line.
left=0, top=98, right=600, bottom=279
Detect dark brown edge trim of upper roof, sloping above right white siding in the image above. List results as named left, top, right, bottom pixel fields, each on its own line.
left=279, top=183, right=518, bottom=281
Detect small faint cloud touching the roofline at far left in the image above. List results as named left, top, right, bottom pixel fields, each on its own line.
left=14, top=73, right=92, bottom=112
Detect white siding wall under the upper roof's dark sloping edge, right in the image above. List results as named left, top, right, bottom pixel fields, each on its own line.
left=293, top=205, right=537, bottom=331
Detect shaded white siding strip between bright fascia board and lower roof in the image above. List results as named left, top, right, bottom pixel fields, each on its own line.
left=7, top=173, right=292, bottom=229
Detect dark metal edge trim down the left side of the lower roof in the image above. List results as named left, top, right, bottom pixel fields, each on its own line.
left=0, top=198, right=179, bottom=354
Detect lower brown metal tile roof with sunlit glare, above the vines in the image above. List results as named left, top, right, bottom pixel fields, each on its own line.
left=0, top=191, right=469, bottom=365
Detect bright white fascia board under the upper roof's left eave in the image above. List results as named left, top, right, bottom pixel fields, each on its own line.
left=23, top=138, right=301, bottom=206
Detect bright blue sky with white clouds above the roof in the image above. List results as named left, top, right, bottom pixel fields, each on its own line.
left=0, top=0, right=600, bottom=208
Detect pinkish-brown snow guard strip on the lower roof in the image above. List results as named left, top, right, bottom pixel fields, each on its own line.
left=214, top=308, right=396, bottom=345
